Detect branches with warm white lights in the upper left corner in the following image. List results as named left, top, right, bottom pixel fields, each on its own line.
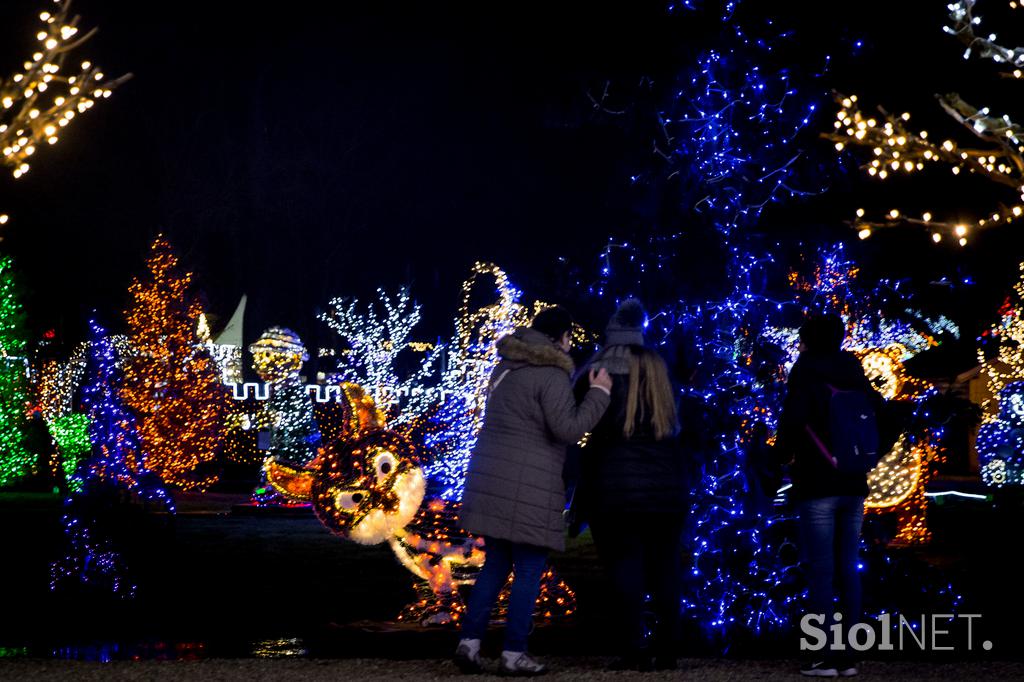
left=0, top=0, right=131, bottom=225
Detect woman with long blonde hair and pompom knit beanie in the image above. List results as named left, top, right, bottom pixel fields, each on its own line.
left=573, top=299, right=688, bottom=671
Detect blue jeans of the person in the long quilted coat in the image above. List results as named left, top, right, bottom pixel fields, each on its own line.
left=462, top=538, right=548, bottom=651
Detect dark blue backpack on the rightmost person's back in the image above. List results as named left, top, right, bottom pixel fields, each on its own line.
left=805, top=386, right=882, bottom=474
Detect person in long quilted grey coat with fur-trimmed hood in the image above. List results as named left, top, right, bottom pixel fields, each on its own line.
left=455, top=306, right=611, bottom=676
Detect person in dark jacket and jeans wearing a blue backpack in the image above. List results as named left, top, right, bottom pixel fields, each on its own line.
left=776, top=314, right=883, bottom=677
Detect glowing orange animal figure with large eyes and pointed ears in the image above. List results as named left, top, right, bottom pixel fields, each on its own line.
left=264, top=384, right=575, bottom=625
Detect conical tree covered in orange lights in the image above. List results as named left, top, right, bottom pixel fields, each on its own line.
left=122, top=237, right=228, bottom=489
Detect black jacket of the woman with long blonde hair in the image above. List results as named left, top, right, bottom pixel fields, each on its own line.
left=573, top=346, right=689, bottom=519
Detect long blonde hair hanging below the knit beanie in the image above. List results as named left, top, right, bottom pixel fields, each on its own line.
left=623, top=346, right=679, bottom=440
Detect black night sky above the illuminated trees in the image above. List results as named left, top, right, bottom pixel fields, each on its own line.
left=0, top=0, right=1024, bottom=372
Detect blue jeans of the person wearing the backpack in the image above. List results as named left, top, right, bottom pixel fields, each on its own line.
left=800, top=495, right=864, bottom=641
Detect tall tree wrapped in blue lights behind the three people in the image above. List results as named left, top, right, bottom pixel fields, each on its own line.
left=591, top=3, right=827, bottom=645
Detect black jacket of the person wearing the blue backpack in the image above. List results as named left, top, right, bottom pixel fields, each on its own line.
left=775, top=351, right=884, bottom=500
